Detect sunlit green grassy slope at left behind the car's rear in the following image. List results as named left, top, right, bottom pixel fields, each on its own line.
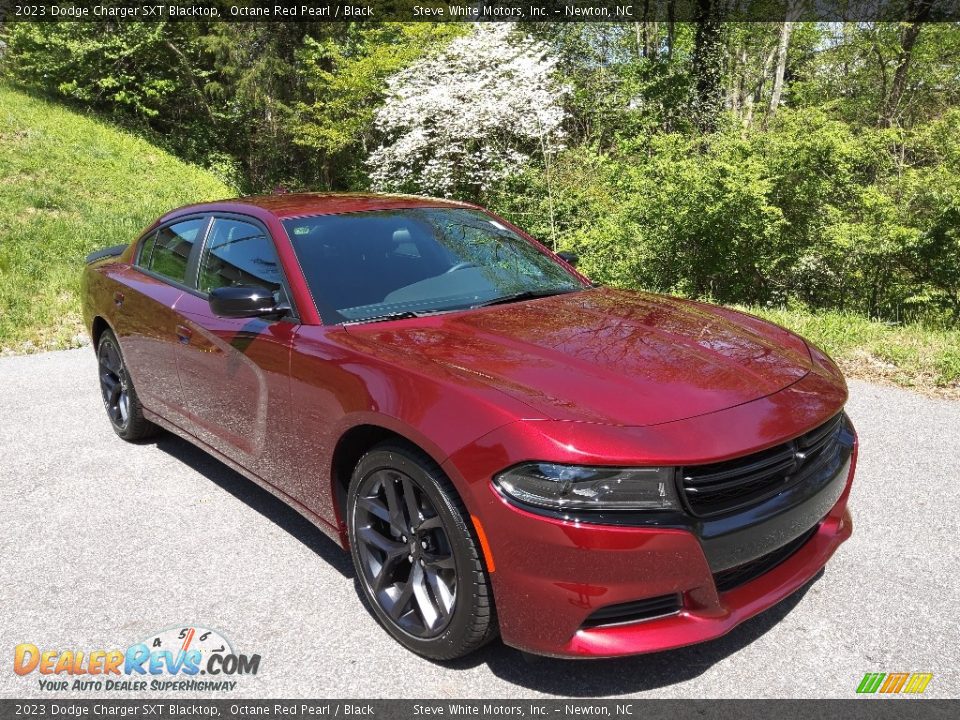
left=0, top=84, right=236, bottom=352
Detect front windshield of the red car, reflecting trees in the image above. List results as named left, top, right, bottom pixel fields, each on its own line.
left=283, top=208, right=586, bottom=324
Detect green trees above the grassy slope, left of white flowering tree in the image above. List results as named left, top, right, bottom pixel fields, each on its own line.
left=2, top=22, right=466, bottom=192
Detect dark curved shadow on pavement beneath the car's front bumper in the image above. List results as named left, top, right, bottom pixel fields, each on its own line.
left=461, top=570, right=823, bottom=697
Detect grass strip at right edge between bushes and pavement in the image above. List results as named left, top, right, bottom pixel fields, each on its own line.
left=744, top=307, right=960, bottom=397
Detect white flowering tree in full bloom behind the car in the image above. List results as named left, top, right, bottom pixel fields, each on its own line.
left=367, top=23, right=568, bottom=196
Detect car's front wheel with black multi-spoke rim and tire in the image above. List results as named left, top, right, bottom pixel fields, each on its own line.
left=347, top=442, right=498, bottom=660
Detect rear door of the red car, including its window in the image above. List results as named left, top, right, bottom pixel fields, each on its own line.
left=113, top=215, right=209, bottom=424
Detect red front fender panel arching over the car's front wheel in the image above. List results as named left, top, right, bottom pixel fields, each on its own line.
left=290, top=326, right=528, bottom=536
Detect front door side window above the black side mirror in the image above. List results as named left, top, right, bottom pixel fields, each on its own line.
left=198, top=218, right=283, bottom=293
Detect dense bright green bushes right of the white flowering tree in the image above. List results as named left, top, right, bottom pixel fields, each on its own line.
left=490, top=109, right=960, bottom=321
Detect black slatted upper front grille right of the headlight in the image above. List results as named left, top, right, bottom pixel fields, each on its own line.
left=680, top=413, right=844, bottom=517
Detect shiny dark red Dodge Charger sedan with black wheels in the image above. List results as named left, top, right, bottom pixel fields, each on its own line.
left=83, top=194, right=857, bottom=659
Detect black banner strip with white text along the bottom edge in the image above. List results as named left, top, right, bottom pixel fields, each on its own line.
left=0, top=697, right=960, bottom=720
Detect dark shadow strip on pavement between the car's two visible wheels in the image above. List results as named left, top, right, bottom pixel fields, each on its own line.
left=155, top=432, right=354, bottom=579
